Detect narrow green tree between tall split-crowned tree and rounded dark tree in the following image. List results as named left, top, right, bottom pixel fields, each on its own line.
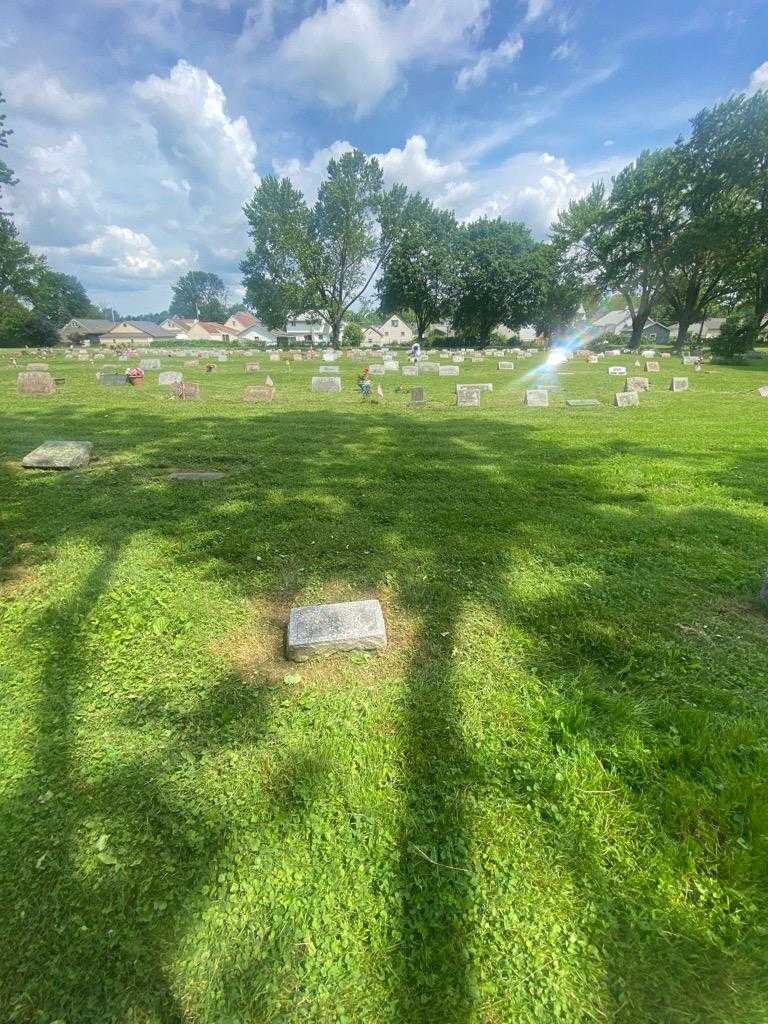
left=377, top=196, right=458, bottom=341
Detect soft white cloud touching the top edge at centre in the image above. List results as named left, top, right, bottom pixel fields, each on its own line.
left=275, top=0, right=489, bottom=116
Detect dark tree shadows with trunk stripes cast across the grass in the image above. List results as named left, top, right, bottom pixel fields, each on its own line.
left=2, top=410, right=768, bottom=1024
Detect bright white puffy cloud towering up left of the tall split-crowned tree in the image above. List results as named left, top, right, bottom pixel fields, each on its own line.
left=133, top=60, right=258, bottom=209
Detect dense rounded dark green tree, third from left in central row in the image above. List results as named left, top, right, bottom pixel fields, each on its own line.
left=452, top=217, right=545, bottom=344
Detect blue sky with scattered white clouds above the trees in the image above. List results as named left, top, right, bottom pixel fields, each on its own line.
left=0, top=0, right=768, bottom=313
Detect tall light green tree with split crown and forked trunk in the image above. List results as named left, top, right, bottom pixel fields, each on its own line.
left=241, top=150, right=408, bottom=345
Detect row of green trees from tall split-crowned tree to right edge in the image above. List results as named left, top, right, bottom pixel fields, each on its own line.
left=242, top=93, right=768, bottom=355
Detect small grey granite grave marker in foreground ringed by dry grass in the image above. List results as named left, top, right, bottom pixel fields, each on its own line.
left=286, top=600, right=387, bottom=662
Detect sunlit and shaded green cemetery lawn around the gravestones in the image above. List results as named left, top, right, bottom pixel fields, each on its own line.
left=0, top=353, right=768, bottom=1024
